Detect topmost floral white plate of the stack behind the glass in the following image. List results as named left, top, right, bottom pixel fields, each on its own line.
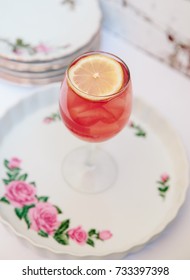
left=0, top=0, right=101, bottom=62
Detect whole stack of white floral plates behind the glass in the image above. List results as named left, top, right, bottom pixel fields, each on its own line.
left=0, top=0, right=101, bottom=85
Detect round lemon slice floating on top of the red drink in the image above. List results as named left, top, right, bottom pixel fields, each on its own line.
left=68, top=54, right=124, bottom=101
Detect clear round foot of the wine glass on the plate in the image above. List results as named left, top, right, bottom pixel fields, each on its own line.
left=61, top=144, right=117, bottom=194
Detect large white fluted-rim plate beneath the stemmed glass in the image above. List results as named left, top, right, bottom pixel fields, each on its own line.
left=0, top=85, right=189, bottom=259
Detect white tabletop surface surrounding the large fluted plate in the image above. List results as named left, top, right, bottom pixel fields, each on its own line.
left=0, top=31, right=190, bottom=260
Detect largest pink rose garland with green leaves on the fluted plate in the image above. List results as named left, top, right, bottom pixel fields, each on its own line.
left=0, top=157, right=112, bottom=247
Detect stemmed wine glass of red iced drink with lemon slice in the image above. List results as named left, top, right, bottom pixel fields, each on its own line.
left=59, top=51, right=132, bottom=194
